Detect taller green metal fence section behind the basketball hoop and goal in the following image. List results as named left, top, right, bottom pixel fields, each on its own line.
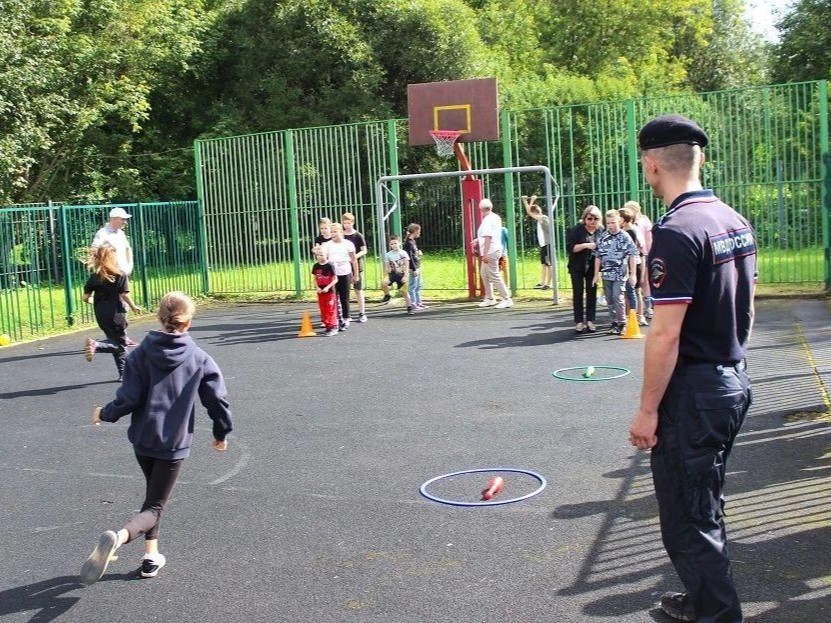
left=195, top=81, right=831, bottom=296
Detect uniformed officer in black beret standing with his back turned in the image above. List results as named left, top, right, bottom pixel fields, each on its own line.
left=629, top=115, right=756, bottom=623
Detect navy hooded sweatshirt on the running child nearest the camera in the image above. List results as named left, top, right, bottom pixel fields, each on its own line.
left=101, top=331, right=232, bottom=460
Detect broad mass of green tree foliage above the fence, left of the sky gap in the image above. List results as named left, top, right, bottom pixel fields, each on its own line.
left=0, top=0, right=788, bottom=203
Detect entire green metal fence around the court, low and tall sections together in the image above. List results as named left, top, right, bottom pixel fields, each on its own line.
left=0, top=81, right=831, bottom=339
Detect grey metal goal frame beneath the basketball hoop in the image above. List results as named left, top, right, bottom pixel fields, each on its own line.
left=376, top=165, right=560, bottom=305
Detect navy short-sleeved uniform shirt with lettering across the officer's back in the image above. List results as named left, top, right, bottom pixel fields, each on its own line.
left=649, top=190, right=757, bottom=363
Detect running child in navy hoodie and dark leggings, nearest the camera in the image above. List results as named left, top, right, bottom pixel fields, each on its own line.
left=81, top=292, right=232, bottom=584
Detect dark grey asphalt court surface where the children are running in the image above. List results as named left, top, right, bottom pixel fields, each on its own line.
left=0, top=300, right=831, bottom=623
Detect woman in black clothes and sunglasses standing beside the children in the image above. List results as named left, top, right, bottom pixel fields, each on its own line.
left=566, top=205, right=602, bottom=333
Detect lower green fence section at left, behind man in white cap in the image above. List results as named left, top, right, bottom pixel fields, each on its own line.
left=0, top=201, right=205, bottom=340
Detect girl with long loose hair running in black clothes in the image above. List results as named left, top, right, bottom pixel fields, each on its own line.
left=84, top=243, right=141, bottom=381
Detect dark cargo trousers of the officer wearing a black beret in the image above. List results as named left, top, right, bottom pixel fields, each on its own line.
left=651, top=362, right=751, bottom=623
